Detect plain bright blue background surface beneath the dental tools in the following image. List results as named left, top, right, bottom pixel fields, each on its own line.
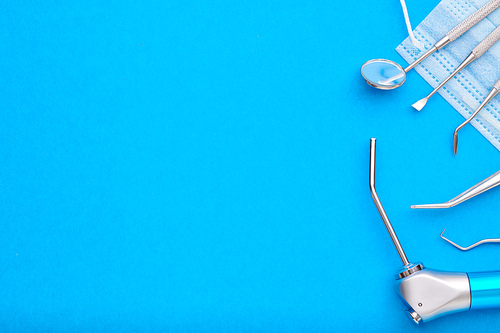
left=0, top=0, right=500, bottom=332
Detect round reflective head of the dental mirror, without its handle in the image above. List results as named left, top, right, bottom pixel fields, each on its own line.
left=361, top=59, right=406, bottom=90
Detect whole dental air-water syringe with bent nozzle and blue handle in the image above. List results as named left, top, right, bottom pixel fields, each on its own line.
left=370, top=138, right=500, bottom=324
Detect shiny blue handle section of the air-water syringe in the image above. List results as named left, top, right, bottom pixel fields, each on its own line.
left=467, top=271, right=500, bottom=310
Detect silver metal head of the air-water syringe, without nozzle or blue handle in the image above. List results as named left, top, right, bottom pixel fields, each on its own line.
left=396, top=269, right=471, bottom=322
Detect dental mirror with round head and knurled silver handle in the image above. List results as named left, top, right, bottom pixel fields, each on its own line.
left=361, top=0, right=500, bottom=90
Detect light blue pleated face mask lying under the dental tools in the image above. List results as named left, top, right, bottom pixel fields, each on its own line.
left=396, top=0, right=500, bottom=150
